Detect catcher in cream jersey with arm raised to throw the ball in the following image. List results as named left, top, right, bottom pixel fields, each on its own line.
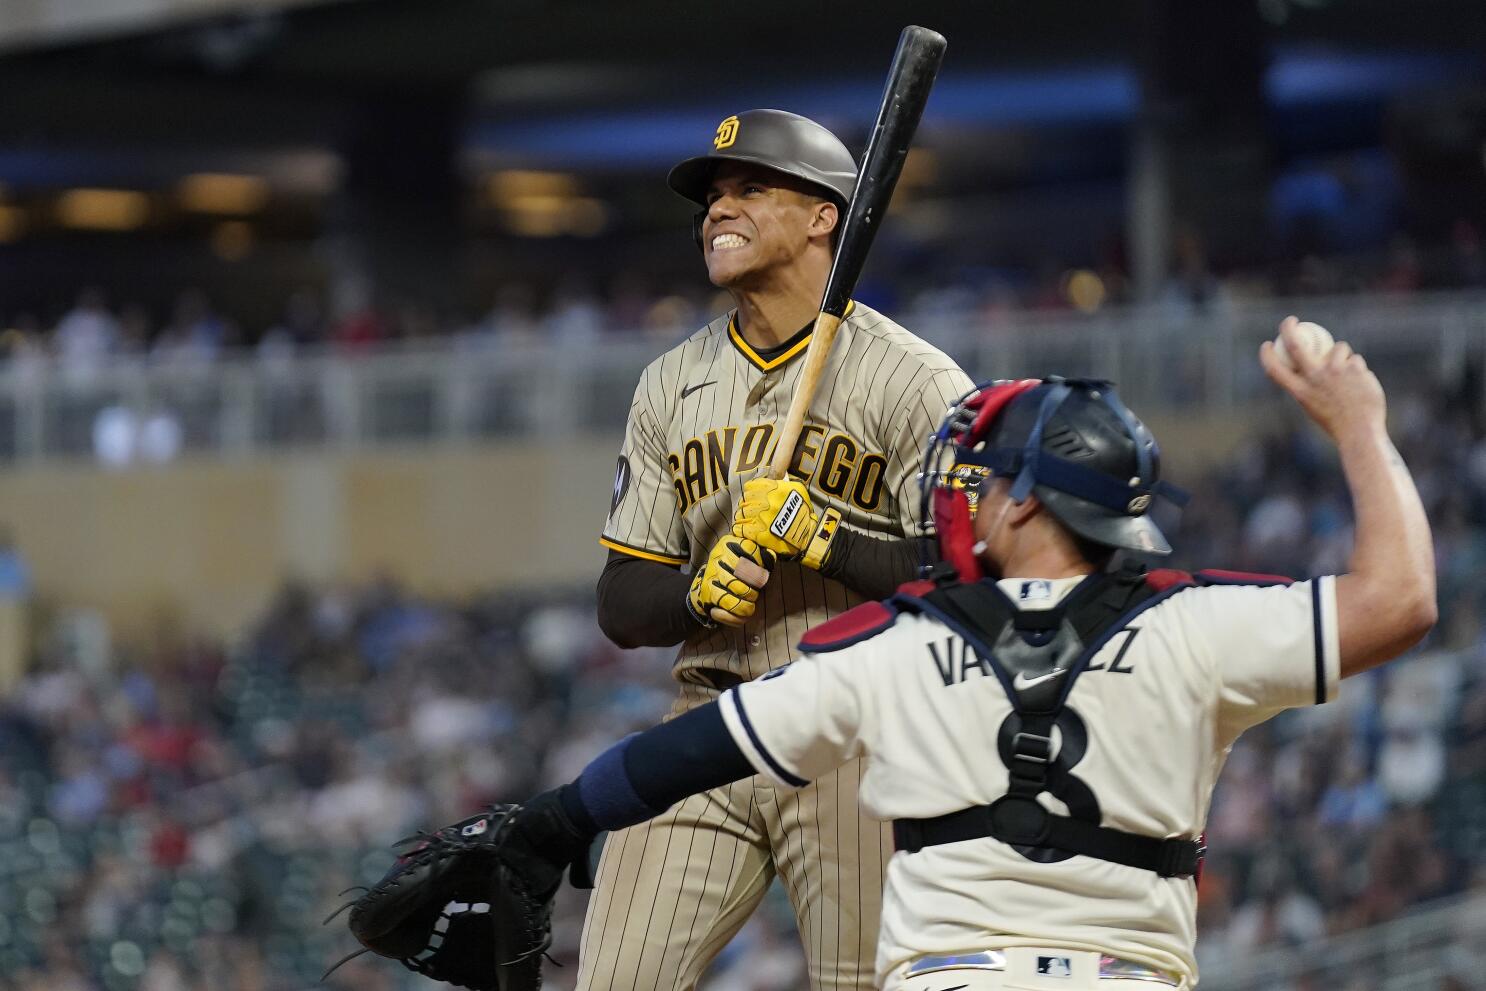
left=478, top=318, right=1435, bottom=991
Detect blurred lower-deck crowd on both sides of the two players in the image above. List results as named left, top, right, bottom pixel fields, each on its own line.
left=0, top=388, right=1486, bottom=991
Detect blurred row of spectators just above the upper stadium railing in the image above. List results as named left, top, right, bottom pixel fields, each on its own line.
left=0, top=220, right=1486, bottom=374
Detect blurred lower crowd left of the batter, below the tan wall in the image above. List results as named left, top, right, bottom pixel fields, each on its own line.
left=0, top=579, right=680, bottom=991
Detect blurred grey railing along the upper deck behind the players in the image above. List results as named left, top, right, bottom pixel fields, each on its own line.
left=0, top=293, right=1486, bottom=464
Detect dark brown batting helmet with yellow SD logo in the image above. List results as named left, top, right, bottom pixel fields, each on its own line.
left=666, top=110, right=856, bottom=209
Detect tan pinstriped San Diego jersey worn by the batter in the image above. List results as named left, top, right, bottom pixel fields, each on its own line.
left=600, top=303, right=973, bottom=689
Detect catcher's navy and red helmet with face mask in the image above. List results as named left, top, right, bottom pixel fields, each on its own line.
left=920, top=377, right=1187, bottom=581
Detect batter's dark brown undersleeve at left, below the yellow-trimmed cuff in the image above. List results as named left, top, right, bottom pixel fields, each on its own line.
left=599, top=551, right=701, bottom=648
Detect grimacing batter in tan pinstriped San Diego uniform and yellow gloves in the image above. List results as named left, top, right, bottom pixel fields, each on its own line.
left=578, top=110, right=972, bottom=991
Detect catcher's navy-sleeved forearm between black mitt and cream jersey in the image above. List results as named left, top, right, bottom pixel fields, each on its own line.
left=560, top=703, right=753, bottom=832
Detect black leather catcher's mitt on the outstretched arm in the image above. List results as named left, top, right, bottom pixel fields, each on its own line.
left=336, top=792, right=588, bottom=991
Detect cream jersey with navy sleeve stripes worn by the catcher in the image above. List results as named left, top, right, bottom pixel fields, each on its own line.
left=721, top=578, right=1340, bottom=987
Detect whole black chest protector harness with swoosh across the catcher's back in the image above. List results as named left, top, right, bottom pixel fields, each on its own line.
left=892, top=568, right=1202, bottom=877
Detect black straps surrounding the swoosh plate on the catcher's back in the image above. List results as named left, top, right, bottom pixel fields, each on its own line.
left=893, top=572, right=1204, bottom=878
